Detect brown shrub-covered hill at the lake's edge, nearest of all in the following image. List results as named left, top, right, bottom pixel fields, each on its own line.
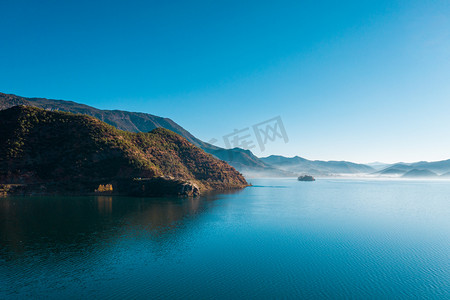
left=0, top=106, right=247, bottom=194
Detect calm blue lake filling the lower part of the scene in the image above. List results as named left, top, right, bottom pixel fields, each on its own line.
left=0, top=179, right=450, bottom=299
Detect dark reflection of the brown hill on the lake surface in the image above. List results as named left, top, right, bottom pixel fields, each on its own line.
left=0, top=194, right=239, bottom=260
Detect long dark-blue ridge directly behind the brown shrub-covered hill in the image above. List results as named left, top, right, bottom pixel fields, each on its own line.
left=0, top=93, right=286, bottom=177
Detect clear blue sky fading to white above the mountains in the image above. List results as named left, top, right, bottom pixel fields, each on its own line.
left=0, top=0, right=450, bottom=162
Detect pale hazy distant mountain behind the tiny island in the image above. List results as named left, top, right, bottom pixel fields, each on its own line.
left=261, top=155, right=375, bottom=176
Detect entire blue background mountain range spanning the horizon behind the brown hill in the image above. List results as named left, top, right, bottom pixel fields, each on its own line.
left=0, top=93, right=450, bottom=177
